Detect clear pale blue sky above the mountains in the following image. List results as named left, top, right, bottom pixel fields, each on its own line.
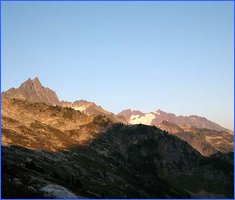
left=1, top=1, right=234, bottom=130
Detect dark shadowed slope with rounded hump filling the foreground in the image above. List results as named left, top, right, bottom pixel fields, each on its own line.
left=2, top=124, right=233, bottom=198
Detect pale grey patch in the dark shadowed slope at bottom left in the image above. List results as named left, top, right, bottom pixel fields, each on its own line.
left=40, top=184, right=78, bottom=198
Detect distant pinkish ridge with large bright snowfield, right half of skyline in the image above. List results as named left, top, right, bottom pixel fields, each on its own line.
left=118, top=109, right=233, bottom=134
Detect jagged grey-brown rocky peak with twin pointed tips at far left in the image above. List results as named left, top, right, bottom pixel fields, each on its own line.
left=2, top=78, right=59, bottom=105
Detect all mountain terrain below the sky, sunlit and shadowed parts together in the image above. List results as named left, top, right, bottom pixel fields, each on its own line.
left=2, top=78, right=234, bottom=198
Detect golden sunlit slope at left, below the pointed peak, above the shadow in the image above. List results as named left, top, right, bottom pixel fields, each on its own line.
left=2, top=97, right=111, bottom=151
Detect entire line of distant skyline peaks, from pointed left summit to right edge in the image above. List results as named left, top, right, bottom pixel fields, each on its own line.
left=2, top=77, right=233, bottom=133
